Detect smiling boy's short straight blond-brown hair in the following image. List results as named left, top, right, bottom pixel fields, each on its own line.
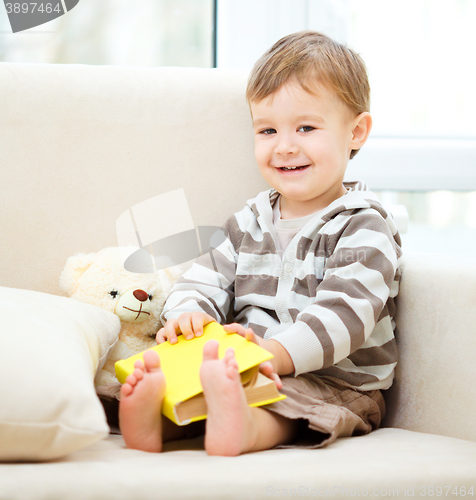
left=246, top=31, right=370, bottom=158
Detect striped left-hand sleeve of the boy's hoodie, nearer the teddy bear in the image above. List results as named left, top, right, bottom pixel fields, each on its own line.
left=161, top=216, right=242, bottom=323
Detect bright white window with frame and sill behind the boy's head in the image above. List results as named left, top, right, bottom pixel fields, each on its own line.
left=217, top=0, right=476, bottom=254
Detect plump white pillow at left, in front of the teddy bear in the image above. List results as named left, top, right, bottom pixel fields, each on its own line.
left=0, top=287, right=121, bottom=461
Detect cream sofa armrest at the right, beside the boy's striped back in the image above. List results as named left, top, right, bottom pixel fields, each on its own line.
left=384, top=254, right=476, bottom=441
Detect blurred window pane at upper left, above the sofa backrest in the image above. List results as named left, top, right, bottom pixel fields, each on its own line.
left=0, top=0, right=214, bottom=67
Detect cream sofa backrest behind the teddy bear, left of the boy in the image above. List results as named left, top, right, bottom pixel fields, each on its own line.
left=0, top=63, right=267, bottom=293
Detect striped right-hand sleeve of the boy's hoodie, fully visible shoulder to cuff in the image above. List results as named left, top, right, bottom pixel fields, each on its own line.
left=273, top=211, right=398, bottom=376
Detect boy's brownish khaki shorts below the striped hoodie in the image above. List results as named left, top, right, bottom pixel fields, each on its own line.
left=262, top=373, right=385, bottom=448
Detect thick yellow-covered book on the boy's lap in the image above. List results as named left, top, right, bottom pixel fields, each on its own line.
left=115, top=322, right=286, bottom=425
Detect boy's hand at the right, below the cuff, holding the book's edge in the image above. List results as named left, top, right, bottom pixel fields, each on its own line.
left=223, top=323, right=294, bottom=389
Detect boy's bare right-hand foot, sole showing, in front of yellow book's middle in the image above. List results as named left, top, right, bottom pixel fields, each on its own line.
left=200, top=340, right=257, bottom=456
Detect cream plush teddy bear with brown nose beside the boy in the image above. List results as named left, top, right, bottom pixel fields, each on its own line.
left=60, top=247, right=184, bottom=399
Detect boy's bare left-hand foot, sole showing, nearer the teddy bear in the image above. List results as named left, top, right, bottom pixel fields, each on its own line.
left=119, top=351, right=165, bottom=452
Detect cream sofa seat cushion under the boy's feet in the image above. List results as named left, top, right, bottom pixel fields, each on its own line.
left=0, top=429, right=476, bottom=500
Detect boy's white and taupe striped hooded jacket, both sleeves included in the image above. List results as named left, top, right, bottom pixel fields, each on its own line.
left=162, top=182, right=401, bottom=391
